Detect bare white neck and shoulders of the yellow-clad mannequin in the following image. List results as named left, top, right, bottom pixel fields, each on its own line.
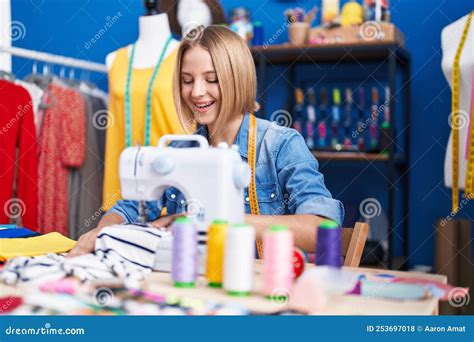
left=105, top=1, right=179, bottom=70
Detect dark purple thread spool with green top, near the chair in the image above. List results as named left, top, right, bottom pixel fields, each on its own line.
left=315, top=220, right=342, bottom=268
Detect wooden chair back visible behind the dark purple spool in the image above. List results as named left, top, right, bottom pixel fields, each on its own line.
left=341, top=222, right=369, bottom=267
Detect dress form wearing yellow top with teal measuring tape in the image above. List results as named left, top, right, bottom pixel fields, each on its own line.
left=102, top=0, right=183, bottom=210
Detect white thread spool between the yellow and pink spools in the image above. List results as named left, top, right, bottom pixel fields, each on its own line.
left=224, top=224, right=255, bottom=296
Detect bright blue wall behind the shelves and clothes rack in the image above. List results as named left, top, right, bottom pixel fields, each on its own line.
left=12, top=0, right=474, bottom=264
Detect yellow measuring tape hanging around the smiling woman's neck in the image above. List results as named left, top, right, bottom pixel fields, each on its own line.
left=247, top=113, right=263, bottom=259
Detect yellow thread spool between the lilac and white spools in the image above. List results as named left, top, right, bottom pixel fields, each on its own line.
left=206, top=220, right=228, bottom=287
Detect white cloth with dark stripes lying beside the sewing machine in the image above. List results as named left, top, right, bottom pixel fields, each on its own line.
left=0, top=225, right=164, bottom=285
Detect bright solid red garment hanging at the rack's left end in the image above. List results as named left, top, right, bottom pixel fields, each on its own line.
left=0, top=80, right=38, bottom=230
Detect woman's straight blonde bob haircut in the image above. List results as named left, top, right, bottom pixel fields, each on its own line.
left=173, top=25, right=259, bottom=133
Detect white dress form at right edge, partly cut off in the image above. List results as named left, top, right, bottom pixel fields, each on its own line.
left=441, top=15, right=474, bottom=189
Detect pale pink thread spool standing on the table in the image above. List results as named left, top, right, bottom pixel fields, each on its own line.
left=263, top=225, right=293, bottom=299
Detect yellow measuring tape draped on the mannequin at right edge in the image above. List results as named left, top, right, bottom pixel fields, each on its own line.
left=451, top=12, right=474, bottom=213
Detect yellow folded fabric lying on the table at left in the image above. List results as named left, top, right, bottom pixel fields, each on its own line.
left=0, top=232, right=76, bottom=260
